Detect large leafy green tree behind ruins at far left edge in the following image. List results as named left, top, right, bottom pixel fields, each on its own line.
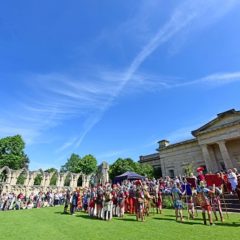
left=0, top=135, right=29, bottom=170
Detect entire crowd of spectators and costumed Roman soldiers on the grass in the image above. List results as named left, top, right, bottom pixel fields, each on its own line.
left=0, top=169, right=240, bottom=225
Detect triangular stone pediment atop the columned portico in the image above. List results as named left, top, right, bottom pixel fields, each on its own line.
left=192, top=109, right=240, bottom=137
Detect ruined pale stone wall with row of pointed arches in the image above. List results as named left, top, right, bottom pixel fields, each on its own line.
left=0, top=162, right=109, bottom=194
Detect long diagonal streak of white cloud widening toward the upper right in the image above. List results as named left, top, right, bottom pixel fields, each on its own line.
left=70, top=0, right=237, bottom=150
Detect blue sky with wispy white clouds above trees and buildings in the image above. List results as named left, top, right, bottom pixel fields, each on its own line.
left=0, top=0, right=240, bottom=169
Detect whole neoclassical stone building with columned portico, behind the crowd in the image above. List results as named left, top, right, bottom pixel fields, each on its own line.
left=139, top=109, right=240, bottom=177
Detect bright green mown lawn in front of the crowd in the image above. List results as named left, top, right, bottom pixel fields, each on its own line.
left=0, top=207, right=240, bottom=240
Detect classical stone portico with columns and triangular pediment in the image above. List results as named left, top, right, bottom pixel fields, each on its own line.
left=192, top=109, right=240, bottom=172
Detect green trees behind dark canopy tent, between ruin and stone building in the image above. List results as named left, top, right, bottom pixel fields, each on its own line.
left=109, top=158, right=153, bottom=179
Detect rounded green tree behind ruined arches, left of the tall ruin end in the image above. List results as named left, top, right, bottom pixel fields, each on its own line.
left=61, top=153, right=97, bottom=174
